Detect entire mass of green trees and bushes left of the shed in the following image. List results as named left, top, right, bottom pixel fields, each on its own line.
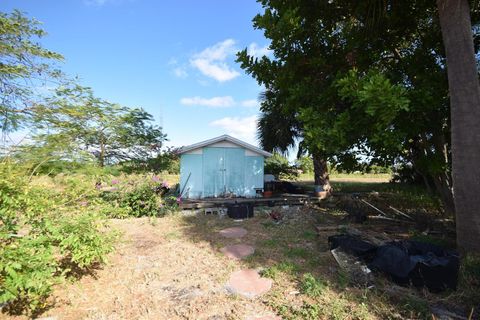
left=0, top=11, right=182, bottom=316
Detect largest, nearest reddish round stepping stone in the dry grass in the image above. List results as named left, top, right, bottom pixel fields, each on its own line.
left=226, top=269, right=273, bottom=298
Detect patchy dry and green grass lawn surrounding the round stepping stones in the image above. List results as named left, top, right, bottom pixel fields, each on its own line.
left=2, top=202, right=472, bottom=320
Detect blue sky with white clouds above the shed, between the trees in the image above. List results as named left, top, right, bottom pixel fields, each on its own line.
left=0, top=0, right=270, bottom=146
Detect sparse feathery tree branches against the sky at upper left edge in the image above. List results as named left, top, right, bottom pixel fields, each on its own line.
left=0, top=11, right=63, bottom=133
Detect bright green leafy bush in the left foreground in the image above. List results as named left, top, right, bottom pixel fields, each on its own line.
left=0, top=162, right=113, bottom=314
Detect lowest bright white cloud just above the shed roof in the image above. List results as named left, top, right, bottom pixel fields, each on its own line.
left=210, top=115, right=258, bottom=144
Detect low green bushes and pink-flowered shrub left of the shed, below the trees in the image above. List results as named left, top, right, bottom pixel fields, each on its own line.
left=0, top=160, right=178, bottom=314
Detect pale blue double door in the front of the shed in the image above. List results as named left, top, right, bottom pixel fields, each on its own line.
left=203, top=148, right=245, bottom=197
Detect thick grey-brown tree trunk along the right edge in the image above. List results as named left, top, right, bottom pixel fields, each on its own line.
left=437, top=0, right=480, bottom=253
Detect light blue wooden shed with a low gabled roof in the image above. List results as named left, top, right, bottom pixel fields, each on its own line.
left=180, top=135, right=272, bottom=199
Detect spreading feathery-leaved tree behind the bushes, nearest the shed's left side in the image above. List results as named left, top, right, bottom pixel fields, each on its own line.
left=34, top=85, right=166, bottom=166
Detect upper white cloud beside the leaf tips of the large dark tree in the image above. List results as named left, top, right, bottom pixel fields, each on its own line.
left=190, top=39, right=240, bottom=82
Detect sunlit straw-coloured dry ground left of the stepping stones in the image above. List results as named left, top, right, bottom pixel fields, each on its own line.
left=31, top=217, right=284, bottom=319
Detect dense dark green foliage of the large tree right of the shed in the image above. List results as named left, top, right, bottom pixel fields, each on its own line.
left=237, top=0, right=458, bottom=211
